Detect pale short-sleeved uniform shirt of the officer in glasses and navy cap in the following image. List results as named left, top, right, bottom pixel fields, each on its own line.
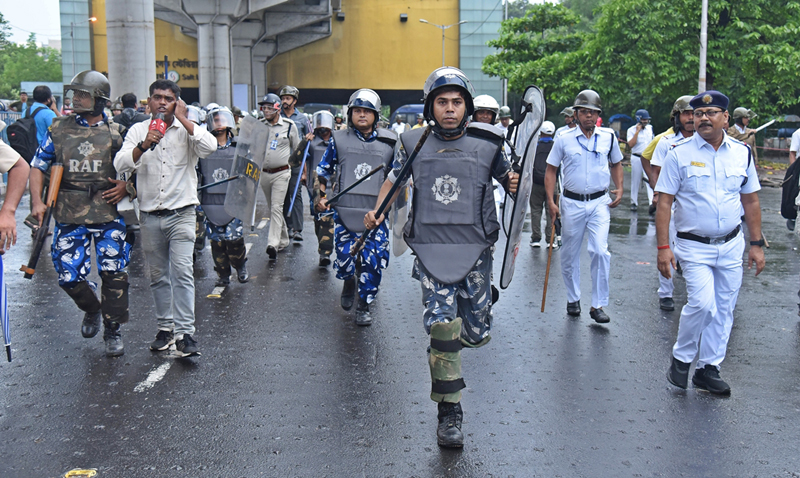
left=656, top=134, right=761, bottom=238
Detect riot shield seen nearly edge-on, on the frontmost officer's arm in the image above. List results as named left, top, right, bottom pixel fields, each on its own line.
left=500, top=85, right=545, bottom=289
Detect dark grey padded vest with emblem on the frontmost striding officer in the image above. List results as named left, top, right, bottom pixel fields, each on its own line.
left=400, top=125, right=502, bottom=284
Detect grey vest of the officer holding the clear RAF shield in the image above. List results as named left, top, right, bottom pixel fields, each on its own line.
left=199, top=139, right=236, bottom=226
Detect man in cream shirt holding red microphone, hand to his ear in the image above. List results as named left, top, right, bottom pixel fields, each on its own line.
left=114, top=79, right=217, bottom=357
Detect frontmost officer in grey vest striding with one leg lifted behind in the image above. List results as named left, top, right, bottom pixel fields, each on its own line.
left=364, top=67, right=517, bottom=447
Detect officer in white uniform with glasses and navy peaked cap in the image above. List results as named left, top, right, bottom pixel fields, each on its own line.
left=656, top=91, right=764, bottom=395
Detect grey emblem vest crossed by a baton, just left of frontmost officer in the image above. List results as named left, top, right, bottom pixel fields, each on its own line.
left=333, top=128, right=397, bottom=232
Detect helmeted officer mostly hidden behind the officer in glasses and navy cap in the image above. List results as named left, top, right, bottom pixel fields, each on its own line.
left=645, top=95, right=694, bottom=311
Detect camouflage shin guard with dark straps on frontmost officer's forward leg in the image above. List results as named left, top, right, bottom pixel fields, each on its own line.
left=428, top=318, right=466, bottom=403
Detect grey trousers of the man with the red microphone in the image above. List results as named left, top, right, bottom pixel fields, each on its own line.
left=139, top=206, right=195, bottom=337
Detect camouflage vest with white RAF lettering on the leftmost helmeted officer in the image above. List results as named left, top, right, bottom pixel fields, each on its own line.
left=50, top=115, right=122, bottom=224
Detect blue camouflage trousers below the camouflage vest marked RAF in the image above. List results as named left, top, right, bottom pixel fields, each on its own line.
left=50, top=216, right=131, bottom=287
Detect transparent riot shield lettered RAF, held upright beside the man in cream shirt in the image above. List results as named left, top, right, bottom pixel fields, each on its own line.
left=225, top=116, right=269, bottom=222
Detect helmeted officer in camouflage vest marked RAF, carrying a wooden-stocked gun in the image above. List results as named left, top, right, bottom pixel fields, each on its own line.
left=30, top=70, right=135, bottom=357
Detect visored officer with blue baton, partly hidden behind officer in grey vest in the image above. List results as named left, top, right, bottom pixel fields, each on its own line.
left=289, top=110, right=334, bottom=267
